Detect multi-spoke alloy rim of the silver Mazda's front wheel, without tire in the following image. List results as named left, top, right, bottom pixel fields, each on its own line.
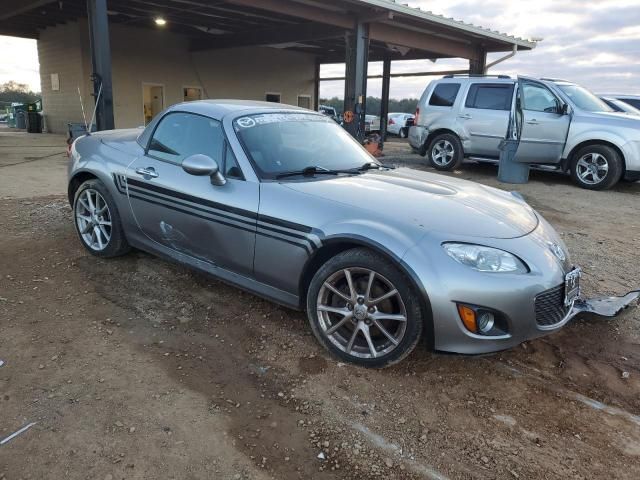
left=316, top=267, right=407, bottom=358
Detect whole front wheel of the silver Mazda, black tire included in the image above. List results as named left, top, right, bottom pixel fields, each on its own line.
left=307, top=248, right=424, bottom=368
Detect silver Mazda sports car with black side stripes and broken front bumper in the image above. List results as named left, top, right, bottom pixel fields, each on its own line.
left=69, top=100, right=638, bottom=367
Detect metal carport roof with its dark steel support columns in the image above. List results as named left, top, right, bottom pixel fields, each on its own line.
left=0, top=0, right=535, bottom=138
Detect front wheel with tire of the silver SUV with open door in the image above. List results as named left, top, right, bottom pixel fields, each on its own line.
left=571, top=145, right=623, bottom=190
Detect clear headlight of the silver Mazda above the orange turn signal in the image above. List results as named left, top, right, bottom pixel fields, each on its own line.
left=442, top=243, right=529, bottom=273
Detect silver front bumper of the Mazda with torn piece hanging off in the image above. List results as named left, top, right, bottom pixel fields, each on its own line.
left=403, top=219, right=640, bottom=354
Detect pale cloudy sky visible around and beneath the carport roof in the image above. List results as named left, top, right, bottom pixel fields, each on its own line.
left=0, top=0, right=640, bottom=98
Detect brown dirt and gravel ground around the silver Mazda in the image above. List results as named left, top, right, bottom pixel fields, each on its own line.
left=0, top=129, right=640, bottom=480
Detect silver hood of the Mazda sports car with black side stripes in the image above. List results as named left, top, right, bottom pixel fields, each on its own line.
left=283, top=168, right=538, bottom=238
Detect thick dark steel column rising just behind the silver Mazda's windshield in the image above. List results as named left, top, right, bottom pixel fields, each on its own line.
left=344, top=21, right=369, bottom=141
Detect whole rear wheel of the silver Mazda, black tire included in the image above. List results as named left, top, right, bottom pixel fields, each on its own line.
left=73, top=179, right=131, bottom=258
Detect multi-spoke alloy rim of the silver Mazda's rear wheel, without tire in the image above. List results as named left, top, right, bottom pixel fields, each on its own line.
left=75, top=188, right=112, bottom=252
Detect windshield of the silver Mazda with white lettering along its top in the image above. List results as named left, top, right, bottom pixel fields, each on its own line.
left=234, top=112, right=375, bottom=179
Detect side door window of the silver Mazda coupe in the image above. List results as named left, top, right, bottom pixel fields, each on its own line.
left=148, top=112, right=225, bottom=165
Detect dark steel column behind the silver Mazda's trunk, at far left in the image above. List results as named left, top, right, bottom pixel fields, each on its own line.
left=87, top=0, right=115, bottom=130
